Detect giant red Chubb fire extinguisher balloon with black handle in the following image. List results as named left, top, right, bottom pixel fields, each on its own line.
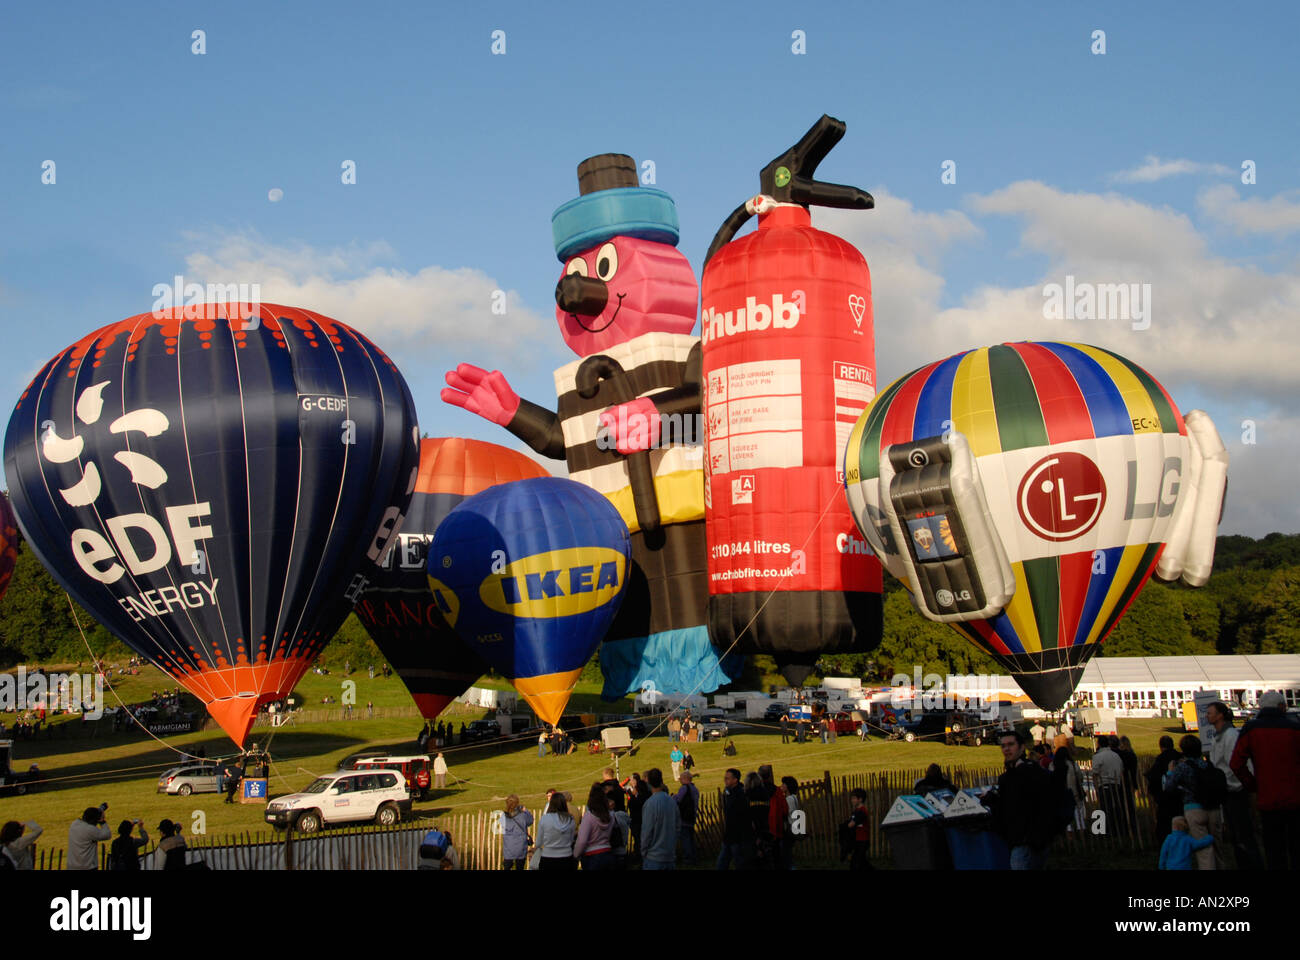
left=701, top=116, right=881, bottom=683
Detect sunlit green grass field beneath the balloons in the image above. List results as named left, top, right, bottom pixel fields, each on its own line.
left=0, top=658, right=1182, bottom=847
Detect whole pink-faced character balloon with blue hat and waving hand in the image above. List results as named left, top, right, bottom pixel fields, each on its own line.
left=442, top=153, right=741, bottom=699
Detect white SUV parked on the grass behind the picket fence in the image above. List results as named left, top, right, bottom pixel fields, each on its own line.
left=267, top=770, right=411, bottom=834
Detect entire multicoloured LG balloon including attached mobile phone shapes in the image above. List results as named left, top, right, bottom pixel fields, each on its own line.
left=845, top=343, right=1227, bottom=710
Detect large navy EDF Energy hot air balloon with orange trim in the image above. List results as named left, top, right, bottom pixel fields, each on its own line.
left=4, top=303, right=419, bottom=745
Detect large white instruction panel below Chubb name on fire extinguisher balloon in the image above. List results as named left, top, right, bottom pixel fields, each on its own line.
left=707, top=359, right=795, bottom=476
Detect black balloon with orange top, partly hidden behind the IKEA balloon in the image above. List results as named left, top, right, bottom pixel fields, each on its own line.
left=355, top=437, right=550, bottom=719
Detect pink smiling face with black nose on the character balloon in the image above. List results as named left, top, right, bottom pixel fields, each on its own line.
left=555, top=237, right=699, bottom=356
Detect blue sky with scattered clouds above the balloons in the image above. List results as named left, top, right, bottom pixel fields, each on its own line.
left=0, top=3, right=1300, bottom=536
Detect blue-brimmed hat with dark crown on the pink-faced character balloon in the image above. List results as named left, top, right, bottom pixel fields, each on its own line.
left=551, top=153, right=681, bottom=263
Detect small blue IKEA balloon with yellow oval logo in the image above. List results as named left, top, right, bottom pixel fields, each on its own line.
left=429, top=477, right=632, bottom=723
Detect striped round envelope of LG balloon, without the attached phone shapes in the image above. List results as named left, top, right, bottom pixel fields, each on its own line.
left=845, top=342, right=1190, bottom=709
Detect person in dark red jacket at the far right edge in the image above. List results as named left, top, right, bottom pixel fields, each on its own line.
left=1230, top=689, right=1300, bottom=870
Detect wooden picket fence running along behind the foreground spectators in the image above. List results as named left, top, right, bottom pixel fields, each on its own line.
left=27, top=757, right=1158, bottom=870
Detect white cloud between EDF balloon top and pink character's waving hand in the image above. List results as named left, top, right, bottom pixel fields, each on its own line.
left=180, top=234, right=555, bottom=368
